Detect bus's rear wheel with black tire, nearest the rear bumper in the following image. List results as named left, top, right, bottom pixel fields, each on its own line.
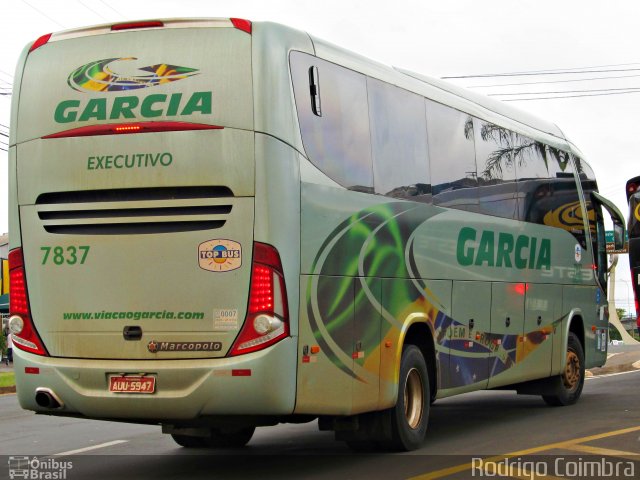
left=384, top=345, right=431, bottom=451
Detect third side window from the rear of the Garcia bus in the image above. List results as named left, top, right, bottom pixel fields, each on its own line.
left=426, top=100, right=478, bottom=212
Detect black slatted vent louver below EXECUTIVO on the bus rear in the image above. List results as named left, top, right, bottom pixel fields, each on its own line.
left=36, top=186, right=233, bottom=235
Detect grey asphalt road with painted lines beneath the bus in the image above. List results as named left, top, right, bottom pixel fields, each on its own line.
left=0, top=371, right=640, bottom=480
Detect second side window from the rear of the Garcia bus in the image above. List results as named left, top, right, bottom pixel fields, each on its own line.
left=367, top=78, right=431, bottom=202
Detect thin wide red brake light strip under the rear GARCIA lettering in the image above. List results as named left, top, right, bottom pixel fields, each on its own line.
left=42, top=122, right=224, bottom=139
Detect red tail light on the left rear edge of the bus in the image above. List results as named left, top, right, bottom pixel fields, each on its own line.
left=9, top=248, right=47, bottom=355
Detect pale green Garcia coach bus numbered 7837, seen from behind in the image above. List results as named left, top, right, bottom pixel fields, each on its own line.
left=9, top=18, right=624, bottom=450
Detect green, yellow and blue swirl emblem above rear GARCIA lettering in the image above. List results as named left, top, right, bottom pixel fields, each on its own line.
left=67, top=57, right=199, bottom=92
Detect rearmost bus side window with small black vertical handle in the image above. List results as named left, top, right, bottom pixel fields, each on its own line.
left=290, top=51, right=373, bottom=193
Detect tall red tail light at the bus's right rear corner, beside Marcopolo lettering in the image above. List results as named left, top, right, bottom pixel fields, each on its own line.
left=229, top=242, right=289, bottom=356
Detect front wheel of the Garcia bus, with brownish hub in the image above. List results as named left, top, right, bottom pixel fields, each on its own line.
left=542, top=332, right=585, bottom=407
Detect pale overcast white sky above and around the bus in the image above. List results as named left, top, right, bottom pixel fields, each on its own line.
left=0, top=0, right=640, bottom=311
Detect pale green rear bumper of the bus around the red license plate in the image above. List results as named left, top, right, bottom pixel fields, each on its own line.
left=14, top=338, right=296, bottom=422
